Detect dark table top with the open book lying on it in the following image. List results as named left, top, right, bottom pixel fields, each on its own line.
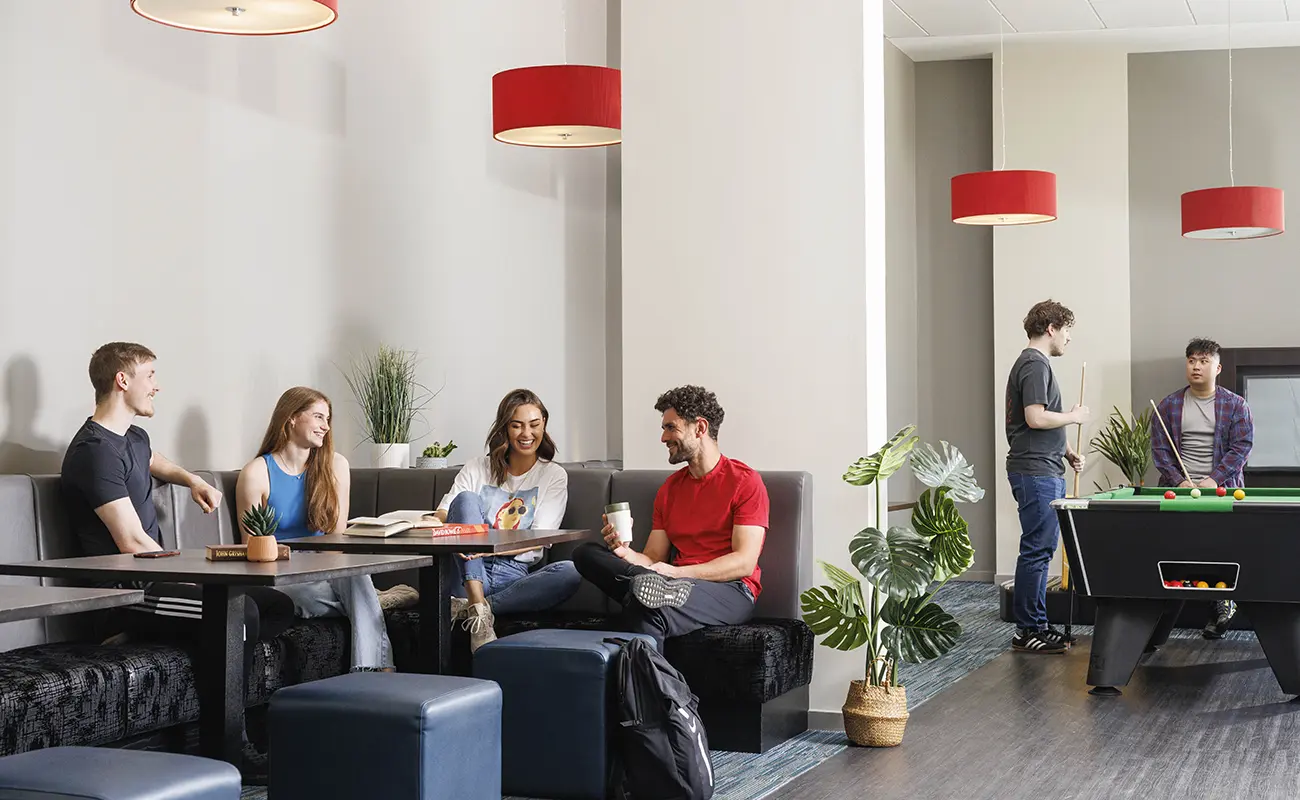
left=278, top=528, right=597, bottom=558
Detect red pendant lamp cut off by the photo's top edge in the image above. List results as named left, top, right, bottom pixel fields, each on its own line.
left=131, top=0, right=338, bottom=36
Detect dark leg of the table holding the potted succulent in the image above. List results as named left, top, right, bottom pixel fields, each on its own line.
left=195, top=584, right=247, bottom=766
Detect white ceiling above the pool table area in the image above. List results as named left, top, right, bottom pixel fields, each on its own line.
left=884, top=0, right=1300, bottom=61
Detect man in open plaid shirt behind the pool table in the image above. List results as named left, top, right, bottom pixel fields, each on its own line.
left=1151, top=340, right=1255, bottom=639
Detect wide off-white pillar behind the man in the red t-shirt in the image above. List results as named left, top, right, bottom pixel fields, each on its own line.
left=621, top=0, right=885, bottom=713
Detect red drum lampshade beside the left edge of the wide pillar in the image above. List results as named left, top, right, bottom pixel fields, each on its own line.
left=491, top=64, right=623, bottom=147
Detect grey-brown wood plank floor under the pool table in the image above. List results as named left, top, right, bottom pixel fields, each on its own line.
left=768, top=639, right=1300, bottom=800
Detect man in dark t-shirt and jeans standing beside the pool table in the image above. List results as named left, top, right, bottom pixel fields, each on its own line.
left=1006, top=300, right=1091, bottom=653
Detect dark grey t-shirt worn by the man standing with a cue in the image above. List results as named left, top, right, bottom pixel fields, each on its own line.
left=1006, top=347, right=1066, bottom=476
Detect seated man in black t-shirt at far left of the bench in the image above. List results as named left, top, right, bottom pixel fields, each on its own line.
left=60, top=342, right=294, bottom=766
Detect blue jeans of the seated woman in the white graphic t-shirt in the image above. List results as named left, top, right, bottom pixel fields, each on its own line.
left=447, top=492, right=582, bottom=614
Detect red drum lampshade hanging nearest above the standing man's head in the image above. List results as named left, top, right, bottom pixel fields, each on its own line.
left=952, top=169, right=1057, bottom=225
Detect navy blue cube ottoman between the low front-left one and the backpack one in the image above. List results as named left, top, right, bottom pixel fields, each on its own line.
left=267, top=673, right=502, bottom=800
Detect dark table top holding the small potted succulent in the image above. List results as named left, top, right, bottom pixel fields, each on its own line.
left=0, top=549, right=433, bottom=587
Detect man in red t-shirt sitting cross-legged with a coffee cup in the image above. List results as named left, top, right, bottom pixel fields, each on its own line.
left=573, top=386, right=768, bottom=650
